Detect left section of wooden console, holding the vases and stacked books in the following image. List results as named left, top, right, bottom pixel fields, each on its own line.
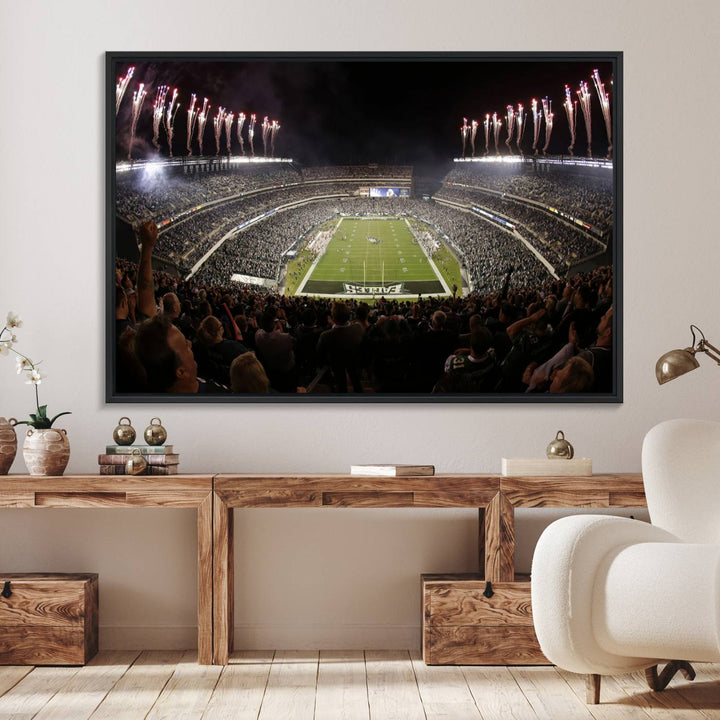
left=0, top=475, right=213, bottom=665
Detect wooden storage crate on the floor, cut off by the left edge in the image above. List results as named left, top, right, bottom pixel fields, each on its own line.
left=0, top=573, right=98, bottom=665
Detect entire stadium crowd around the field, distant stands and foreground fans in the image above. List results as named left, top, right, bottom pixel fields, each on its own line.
left=116, top=163, right=613, bottom=394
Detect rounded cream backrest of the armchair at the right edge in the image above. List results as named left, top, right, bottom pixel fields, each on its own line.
left=642, top=420, right=720, bottom=544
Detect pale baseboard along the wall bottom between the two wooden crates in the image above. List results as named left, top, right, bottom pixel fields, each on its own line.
left=100, top=624, right=421, bottom=650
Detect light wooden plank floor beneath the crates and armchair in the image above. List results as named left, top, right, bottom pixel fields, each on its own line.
left=0, top=650, right=720, bottom=720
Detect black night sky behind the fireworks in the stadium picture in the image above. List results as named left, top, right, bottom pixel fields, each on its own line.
left=108, top=55, right=614, bottom=166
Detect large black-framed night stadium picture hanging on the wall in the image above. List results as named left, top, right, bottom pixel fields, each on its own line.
left=106, top=52, right=622, bottom=403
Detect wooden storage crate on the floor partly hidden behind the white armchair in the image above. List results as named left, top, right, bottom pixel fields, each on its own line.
left=422, top=574, right=549, bottom=665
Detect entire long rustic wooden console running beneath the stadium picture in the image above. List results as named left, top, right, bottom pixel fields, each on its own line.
left=0, top=474, right=645, bottom=665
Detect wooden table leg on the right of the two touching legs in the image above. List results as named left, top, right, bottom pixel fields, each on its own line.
left=213, top=492, right=235, bottom=665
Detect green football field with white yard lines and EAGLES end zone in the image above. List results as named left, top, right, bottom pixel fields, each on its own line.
left=298, top=218, right=447, bottom=296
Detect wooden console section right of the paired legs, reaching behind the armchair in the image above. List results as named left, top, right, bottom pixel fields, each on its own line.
left=213, top=474, right=645, bottom=665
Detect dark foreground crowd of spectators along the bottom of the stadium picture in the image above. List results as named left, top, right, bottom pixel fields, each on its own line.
left=116, top=223, right=613, bottom=395
